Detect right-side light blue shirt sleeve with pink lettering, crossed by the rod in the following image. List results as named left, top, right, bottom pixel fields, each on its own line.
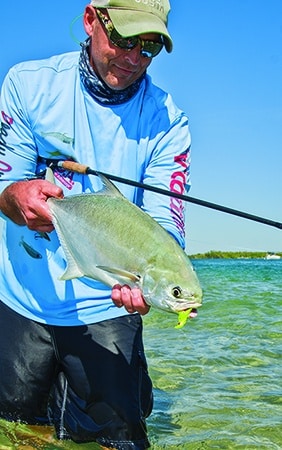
left=142, top=109, right=191, bottom=248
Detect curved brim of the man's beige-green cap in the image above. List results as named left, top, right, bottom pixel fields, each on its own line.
left=107, top=8, right=173, bottom=53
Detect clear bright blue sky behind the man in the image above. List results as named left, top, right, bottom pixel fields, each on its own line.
left=0, top=0, right=282, bottom=253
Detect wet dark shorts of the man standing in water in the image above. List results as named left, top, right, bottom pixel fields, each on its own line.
left=0, top=302, right=153, bottom=450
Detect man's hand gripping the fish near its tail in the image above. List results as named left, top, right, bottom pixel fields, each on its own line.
left=0, top=180, right=63, bottom=233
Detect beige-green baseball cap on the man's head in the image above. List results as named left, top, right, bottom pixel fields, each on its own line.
left=91, top=0, right=173, bottom=53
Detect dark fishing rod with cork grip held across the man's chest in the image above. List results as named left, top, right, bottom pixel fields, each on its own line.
left=50, top=161, right=282, bottom=230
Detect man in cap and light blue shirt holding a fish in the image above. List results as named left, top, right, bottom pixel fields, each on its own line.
left=0, top=0, right=190, bottom=450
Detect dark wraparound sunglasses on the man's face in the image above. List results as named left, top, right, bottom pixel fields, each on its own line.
left=95, top=8, right=164, bottom=58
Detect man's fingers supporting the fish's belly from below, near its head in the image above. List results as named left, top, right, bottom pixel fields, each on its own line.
left=112, top=284, right=150, bottom=315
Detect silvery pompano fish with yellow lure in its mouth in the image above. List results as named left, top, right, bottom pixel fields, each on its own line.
left=48, top=176, right=202, bottom=328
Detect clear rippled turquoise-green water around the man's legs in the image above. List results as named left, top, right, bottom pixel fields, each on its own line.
left=0, top=259, right=282, bottom=450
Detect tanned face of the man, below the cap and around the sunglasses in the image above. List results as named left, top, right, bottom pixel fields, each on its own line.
left=84, top=5, right=158, bottom=90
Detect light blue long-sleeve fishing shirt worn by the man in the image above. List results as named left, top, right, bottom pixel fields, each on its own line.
left=0, top=52, right=190, bottom=325
